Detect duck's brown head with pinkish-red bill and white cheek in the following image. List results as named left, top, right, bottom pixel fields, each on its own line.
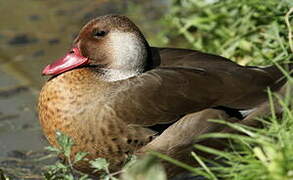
left=43, top=15, right=152, bottom=81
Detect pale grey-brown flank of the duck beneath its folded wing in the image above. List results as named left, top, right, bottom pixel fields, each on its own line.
left=140, top=83, right=293, bottom=178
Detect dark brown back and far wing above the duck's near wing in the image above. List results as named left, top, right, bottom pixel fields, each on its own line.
left=151, top=47, right=293, bottom=108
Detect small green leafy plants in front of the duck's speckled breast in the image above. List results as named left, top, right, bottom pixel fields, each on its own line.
left=40, top=132, right=166, bottom=180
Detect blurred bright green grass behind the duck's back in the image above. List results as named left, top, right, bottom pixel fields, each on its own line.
left=160, top=0, right=293, bottom=64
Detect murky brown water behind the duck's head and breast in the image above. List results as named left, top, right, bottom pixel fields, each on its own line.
left=0, top=0, right=168, bottom=177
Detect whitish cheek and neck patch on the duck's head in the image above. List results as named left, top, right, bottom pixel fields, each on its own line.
left=104, top=31, right=147, bottom=81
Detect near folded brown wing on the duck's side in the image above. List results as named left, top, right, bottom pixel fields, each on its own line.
left=108, top=67, right=270, bottom=125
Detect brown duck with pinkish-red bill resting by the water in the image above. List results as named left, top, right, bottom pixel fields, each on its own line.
left=38, top=15, right=293, bottom=176
